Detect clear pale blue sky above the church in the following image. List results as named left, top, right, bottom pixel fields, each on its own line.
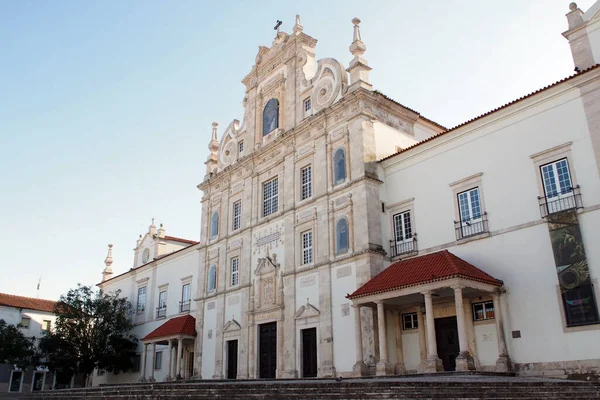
left=0, top=0, right=593, bottom=299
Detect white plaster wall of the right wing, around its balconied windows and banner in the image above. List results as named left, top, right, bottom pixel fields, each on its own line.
left=381, top=89, right=600, bottom=362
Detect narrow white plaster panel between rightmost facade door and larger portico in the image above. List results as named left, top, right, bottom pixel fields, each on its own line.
left=331, top=263, right=356, bottom=373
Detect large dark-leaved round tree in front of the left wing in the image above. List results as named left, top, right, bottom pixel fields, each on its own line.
left=40, top=285, right=137, bottom=381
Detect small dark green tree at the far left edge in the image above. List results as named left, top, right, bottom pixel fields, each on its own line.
left=0, top=319, right=38, bottom=369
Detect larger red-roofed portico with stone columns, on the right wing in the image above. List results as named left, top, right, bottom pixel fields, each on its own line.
left=347, top=251, right=510, bottom=376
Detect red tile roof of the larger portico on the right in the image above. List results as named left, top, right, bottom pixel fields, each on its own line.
left=347, top=250, right=503, bottom=299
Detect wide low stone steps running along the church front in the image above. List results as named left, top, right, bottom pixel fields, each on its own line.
left=29, top=375, right=600, bottom=400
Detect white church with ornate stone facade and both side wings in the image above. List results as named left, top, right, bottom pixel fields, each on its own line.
left=94, top=1, right=600, bottom=384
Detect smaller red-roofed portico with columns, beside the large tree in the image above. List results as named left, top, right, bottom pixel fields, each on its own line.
left=139, top=315, right=196, bottom=382
